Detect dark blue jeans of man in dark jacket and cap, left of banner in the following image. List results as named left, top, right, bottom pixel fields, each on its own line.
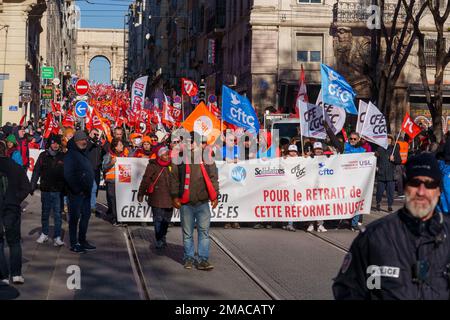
left=69, top=194, right=91, bottom=247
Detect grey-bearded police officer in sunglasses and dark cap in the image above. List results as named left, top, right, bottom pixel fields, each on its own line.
left=333, top=153, right=450, bottom=300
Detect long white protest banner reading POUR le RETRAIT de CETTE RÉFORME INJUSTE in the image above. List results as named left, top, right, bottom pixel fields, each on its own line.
left=116, top=153, right=376, bottom=222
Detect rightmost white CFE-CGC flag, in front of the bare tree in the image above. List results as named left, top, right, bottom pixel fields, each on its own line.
left=361, top=102, right=388, bottom=149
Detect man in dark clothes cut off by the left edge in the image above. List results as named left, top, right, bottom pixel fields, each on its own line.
left=0, top=141, right=31, bottom=284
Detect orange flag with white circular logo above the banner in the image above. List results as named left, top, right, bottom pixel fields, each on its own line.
left=181, top=102, right=226, bottom=144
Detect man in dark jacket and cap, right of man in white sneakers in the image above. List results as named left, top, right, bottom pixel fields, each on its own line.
left=64, top=131, right=96, bottom=253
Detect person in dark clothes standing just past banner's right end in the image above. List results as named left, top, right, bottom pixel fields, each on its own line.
left=375, top=135, right=402, bottom=212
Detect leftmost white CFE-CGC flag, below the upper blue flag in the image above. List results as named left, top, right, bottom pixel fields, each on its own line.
left=297, top=100, right=327, bottom=139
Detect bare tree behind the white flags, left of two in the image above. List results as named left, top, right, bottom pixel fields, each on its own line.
left=374, top=0, right=427, bottom=129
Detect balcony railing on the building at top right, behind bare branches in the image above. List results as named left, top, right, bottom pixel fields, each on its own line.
left=334, top=0, right=406, bottom=23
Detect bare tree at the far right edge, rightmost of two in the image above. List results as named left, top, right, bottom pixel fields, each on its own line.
left=402, top=0, right=450, bottom=141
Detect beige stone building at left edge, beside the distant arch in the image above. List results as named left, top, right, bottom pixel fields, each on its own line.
left=0, top=0, right=76, bottom=124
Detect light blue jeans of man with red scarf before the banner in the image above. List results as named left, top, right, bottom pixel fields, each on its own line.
left=180, top=202, right=211, bottom=261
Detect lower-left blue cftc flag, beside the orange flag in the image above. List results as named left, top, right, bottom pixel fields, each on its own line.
left=222, top=86, right=259, bottom=133
